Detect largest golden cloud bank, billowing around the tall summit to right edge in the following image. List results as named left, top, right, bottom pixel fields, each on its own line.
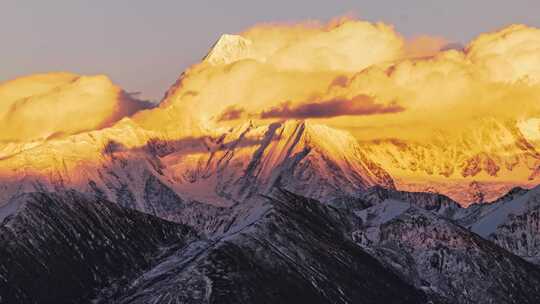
left=136, top=19, right=540, bottom=137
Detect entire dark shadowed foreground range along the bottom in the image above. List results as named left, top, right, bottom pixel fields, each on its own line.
left=0, top=188, right=540, bottom=304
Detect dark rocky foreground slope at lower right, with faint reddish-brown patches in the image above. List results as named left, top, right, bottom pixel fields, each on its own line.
left=353, top=199, right=540, bottom=303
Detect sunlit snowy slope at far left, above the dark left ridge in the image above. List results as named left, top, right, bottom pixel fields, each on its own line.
left=0, top=119, right=190, bottom=218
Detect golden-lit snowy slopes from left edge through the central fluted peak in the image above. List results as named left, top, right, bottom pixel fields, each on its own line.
left=0, top=120, right=393, bottom=220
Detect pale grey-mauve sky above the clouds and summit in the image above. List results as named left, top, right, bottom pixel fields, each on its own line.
left=0, top=0, right=540, bottom=100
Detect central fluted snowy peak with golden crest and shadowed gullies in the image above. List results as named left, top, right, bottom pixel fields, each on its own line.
left=161, top=121, right=393, bottom=201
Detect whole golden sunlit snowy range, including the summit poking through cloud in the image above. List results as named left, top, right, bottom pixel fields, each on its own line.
left=0, top=35, right=540, bottom=214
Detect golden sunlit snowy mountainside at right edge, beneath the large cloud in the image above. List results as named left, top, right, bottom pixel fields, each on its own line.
left=362, top=118, right=540, bottom=205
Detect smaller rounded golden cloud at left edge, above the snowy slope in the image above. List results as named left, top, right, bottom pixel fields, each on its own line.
left=0, top=73, right=149, bottom=141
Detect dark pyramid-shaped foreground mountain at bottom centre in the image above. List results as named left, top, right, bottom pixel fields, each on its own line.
left=103, top=191, right=426, bottom=303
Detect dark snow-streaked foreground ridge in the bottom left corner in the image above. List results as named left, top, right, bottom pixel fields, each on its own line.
left=0, top=192, right=196, bottom=303
